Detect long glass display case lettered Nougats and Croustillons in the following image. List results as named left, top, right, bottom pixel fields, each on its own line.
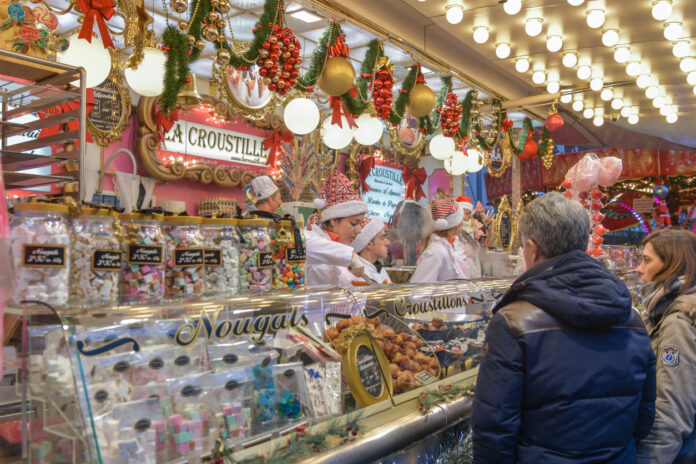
left=8, top=279, right=511, bottom=463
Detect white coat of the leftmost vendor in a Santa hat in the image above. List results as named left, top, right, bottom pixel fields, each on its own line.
left=304, top=224, right=355, bottom=288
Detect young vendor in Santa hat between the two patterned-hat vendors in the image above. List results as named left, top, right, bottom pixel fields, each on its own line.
left=352, top=218, right=392, bottom=284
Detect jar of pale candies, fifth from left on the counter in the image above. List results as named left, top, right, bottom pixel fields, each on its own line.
left=203, top=218, right=240, bottom=295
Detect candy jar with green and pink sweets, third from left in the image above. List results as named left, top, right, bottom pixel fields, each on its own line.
left=121, top=213, right=164, bottom=300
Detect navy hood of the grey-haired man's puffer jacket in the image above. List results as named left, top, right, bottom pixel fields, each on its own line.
left=493, top=250, right=632, bottom=328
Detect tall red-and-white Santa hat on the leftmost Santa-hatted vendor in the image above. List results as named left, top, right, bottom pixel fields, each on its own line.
left=314, top=171, right=368, bottom=222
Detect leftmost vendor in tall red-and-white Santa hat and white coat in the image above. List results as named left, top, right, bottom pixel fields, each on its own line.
left=305, top=171, right=368, bottom=287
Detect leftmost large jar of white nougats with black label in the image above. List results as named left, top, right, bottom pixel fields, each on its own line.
left=10, top=203, right=70, bottom=305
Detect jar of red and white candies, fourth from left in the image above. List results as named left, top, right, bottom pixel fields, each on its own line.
left=162, top=216, right=205, bottom=296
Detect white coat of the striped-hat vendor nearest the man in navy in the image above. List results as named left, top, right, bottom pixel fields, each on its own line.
left=411, top=234, right=469, bottom=283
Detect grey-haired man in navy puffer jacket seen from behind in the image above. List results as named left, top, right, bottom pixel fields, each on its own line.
left=472, top=193, right=655, bottom=464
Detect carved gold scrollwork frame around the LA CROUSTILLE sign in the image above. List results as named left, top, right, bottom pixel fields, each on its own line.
left=136, top=95, right=285, bottom=187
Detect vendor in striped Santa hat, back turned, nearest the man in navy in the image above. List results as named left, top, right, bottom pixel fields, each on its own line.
left=411, top=199, right=469, bottom=283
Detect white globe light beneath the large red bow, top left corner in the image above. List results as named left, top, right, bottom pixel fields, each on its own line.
left=56, top=32, right=111, bottom=87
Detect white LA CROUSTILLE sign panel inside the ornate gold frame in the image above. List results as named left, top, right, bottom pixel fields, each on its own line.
left=164, top=121, right=268, bottom=166
